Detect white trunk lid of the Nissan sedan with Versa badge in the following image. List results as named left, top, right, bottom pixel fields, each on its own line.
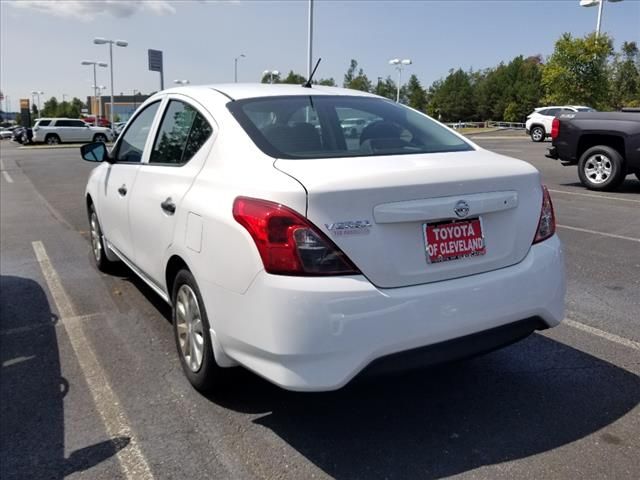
left=274, top=149, right=542, bottom=288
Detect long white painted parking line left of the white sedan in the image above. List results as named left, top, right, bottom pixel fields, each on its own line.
left=31, top=241, right=153, bottom=480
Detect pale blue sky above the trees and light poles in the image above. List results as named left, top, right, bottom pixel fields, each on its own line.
left=0, top=0, right=640, bottom=111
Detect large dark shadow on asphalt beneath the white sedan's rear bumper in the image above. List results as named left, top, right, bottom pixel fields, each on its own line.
left=210, top=334, right=640, bottom=479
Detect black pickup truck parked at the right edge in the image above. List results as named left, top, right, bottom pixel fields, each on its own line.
left=546, top=112, right=640, bottom=190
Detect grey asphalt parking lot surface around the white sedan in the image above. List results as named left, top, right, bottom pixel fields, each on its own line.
left=0, top=136, right=640, bottom=480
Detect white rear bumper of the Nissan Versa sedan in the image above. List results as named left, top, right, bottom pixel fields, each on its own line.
left=203, top=236, right=565, bottom=391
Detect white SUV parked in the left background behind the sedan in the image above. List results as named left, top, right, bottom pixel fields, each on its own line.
left=32, top=118, right=113, bottom=145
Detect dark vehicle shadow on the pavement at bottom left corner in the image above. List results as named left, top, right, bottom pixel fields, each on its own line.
left=0, top=275, right=130, bottom=480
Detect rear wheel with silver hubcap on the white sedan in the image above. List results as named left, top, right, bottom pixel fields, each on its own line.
left=171, top=269, right=223, bottom=392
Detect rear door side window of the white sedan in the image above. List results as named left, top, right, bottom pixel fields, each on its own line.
left=149, top=100, right=212, bottom=165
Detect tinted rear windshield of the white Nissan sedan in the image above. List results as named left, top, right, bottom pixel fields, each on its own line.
left=227, top=95, right=473, bottom=159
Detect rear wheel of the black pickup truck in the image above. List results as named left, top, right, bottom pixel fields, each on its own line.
left=578, top=145, right=625, bottom=190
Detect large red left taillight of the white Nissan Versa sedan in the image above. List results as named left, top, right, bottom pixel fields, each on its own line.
left=233, top=197, right=360, bottom=276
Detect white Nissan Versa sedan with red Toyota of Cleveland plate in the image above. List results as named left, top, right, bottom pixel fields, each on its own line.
left=82, top=84, right=565, bottom=391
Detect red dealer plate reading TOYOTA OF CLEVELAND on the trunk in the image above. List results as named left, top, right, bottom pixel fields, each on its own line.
left=423, top=218, right=487, bottom=263
